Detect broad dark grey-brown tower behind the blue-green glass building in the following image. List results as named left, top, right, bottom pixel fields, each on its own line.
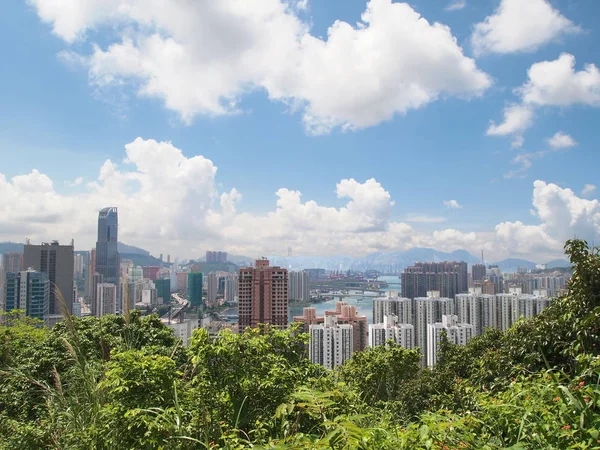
left=23, top=241, right=75, bottom=315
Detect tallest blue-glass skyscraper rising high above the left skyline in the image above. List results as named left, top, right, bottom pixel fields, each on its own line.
left=95, top=207, right=122, bottom=311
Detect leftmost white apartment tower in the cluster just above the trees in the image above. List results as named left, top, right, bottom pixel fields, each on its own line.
left=308, top=316, right=354, bottom=369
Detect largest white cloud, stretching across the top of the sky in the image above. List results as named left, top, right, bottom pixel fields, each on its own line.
left=30, top=0, right=491, bottom=134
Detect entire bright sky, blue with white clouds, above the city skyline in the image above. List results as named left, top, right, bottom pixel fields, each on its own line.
left=0, top=0, right=600, bottom=260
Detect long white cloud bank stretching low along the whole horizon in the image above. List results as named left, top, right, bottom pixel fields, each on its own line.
left=0, top=138, right=600, bottom=261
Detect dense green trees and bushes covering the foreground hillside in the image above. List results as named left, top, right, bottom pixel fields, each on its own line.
left=0, top=240, right=600, bottom=449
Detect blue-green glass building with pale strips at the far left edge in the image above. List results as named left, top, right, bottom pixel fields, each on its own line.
left=4, top=270, right=50, bottom=320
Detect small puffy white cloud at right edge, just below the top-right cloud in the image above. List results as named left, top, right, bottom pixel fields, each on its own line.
left=518, top=53, right=600, bottom=107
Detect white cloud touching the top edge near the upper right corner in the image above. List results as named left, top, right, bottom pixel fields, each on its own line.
left=471, top=0, right=580, bottom=54
